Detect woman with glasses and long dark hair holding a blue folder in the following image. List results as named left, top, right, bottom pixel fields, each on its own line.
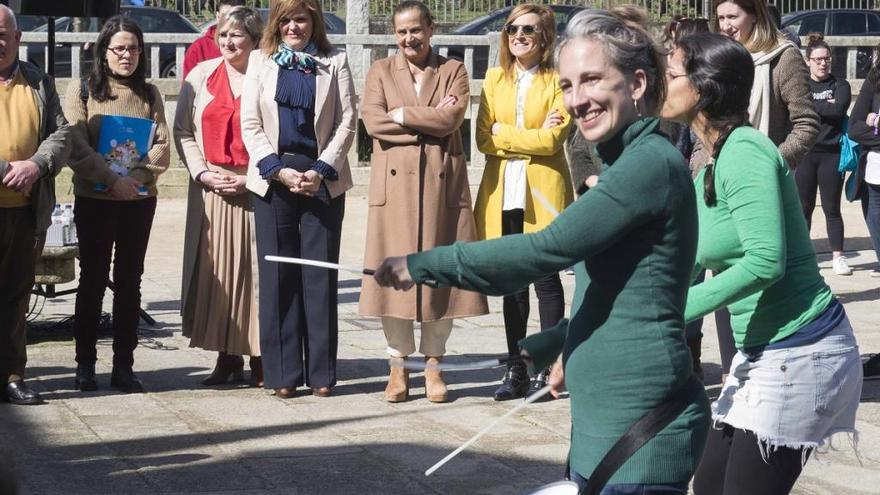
left=64, top=16, right=170, bottom=393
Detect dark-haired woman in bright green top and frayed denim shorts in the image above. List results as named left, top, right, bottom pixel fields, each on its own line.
left=661, top=33, right=862, bottom=495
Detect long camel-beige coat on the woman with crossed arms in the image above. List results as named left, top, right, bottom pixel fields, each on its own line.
left=360, top=54, right=488, bottom=321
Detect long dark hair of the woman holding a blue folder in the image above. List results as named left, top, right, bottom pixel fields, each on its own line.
left=89, top=15, right=153, bottom=105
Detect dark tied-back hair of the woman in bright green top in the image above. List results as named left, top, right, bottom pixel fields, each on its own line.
left=677, top=33, right=755, bottom=206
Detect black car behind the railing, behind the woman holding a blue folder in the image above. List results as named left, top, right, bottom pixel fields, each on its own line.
left=27, top=6, right=199, bottom=78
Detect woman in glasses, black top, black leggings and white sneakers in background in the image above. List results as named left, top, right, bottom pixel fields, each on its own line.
left=795, top=33, right=852, bottom=275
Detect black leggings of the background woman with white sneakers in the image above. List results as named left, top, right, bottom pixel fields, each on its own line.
left=794, top=151, right=843, bottom=251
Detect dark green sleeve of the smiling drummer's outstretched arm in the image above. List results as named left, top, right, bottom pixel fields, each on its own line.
left=407, top=138, right=668, bottom=296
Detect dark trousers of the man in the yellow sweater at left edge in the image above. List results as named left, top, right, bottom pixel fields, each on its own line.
left=0, top=206, right=42, bottom=380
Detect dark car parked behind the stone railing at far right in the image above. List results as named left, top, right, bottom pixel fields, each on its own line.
left=782, top=9, right=880, bottom=78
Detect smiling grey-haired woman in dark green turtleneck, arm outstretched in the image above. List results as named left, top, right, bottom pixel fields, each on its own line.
left=376, top=9, right=709, bottom=494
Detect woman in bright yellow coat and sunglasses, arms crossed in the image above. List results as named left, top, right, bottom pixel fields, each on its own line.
left=474, top=4, right=574, bottom=400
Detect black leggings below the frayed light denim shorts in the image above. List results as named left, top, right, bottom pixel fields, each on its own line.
left=694, top=425, right=809, bottom=495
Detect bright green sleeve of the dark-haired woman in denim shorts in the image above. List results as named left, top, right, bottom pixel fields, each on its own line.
left=685, top=136, right=786, bottom=321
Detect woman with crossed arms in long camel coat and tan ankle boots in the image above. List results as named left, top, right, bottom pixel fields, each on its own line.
left=360, top=1, right=488, bottom=402
